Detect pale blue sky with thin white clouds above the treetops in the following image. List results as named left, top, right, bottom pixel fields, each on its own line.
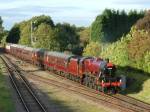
left=0, top=0, right=150, bottom=30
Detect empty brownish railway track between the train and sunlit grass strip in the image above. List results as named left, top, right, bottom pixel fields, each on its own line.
left=26, top=75, right=150, bottom=112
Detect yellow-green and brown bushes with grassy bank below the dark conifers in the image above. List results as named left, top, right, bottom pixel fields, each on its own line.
left=83, top=11, right=150, bottom=103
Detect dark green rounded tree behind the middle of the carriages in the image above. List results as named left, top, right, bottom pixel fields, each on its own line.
left=56, top=23, right=80, bottom=51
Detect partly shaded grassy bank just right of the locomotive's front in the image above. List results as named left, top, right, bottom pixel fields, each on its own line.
left=119, top=70, right=150, bottom=104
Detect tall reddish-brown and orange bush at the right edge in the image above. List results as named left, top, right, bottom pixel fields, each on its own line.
left=127, top=14, right=150, bottom=72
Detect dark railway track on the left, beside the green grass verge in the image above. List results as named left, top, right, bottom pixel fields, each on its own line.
left=0, top=56, right=47, bottom=112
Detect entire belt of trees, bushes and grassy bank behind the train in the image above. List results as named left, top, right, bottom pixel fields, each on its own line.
left=0, top=9, right=150, bottom=103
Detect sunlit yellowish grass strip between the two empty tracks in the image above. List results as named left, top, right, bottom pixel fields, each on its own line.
left=40, top=84, right=112, bottom=112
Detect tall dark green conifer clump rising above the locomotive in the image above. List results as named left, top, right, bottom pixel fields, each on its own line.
left=91, top=9, right=144, bottom=43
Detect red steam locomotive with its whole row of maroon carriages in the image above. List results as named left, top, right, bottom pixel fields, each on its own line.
left=5, top=44, right=122, bottom=93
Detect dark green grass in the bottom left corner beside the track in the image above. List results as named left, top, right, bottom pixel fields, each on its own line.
left=0, top=66, right=15, bottom=112
